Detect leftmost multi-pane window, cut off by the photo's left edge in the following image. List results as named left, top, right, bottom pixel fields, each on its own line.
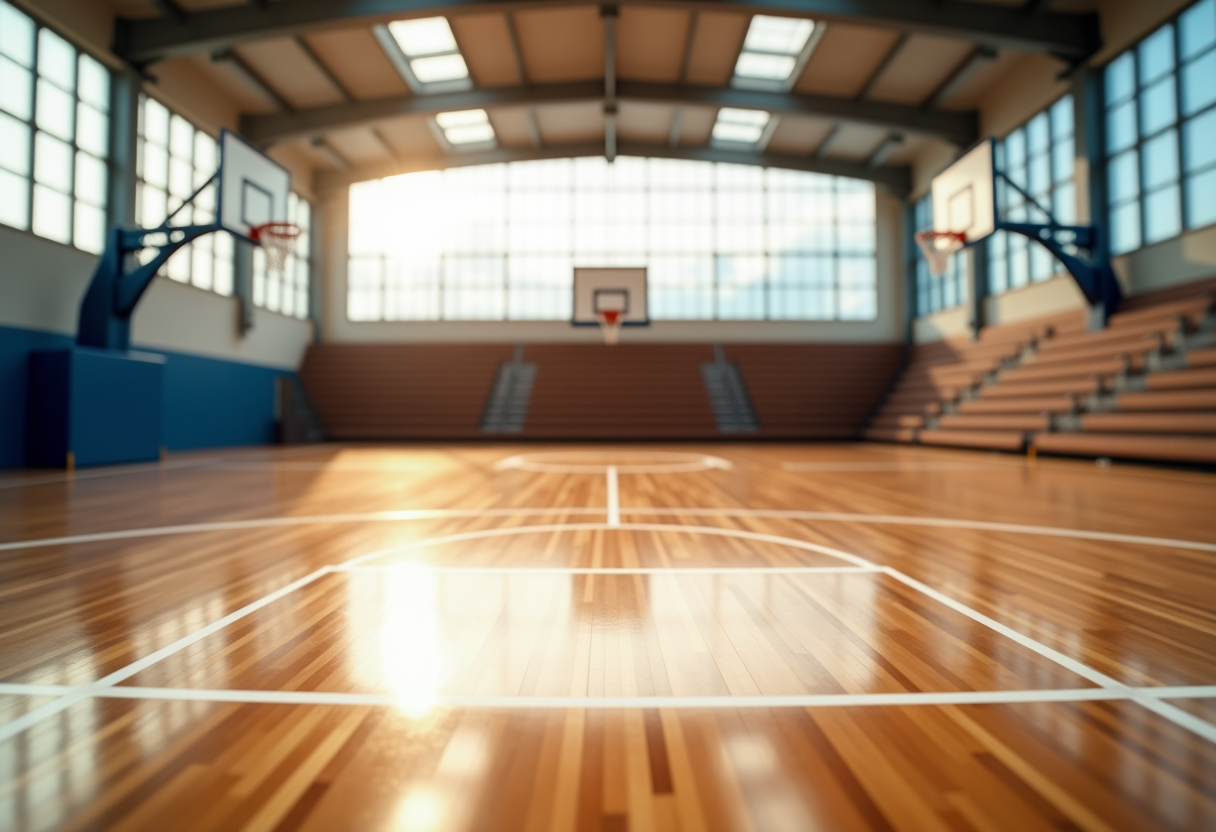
left=0, top=0, right=109, bottom=253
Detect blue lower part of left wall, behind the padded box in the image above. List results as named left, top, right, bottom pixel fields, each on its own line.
left=0, top=326, right=294, bottom=468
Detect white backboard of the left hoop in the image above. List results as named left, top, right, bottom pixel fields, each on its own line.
left=219, top=130, right=292, bottom=240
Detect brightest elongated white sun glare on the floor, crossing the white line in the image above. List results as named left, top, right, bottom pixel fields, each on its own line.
left=379, top=563, right=450, bottom=718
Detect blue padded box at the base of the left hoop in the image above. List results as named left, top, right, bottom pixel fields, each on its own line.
left=27, top=347, right=165, bottom=467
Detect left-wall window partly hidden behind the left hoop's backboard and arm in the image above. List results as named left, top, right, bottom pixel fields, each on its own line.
left=135, top=95, right=232, bottom=294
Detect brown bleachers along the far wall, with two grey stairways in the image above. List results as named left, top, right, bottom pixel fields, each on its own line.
left=300, top=343, right=903, bottom=439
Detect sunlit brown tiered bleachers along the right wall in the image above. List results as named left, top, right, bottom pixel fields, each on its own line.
left=866, top=281, right=1216, bottom=462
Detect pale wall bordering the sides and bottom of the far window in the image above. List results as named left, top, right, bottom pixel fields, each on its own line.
left=322, top=183, right=905, bottom=343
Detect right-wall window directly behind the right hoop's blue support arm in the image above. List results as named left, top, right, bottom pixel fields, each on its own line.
left=987, top=95, right=1076, bottom=294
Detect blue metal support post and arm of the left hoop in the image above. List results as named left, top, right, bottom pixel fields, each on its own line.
left=77, top=223, right=221, bottom=350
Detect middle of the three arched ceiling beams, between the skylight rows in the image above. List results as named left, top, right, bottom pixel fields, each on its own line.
left=241, top=80, right=979, bottom=147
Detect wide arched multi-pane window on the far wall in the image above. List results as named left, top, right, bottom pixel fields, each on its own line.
left=347, top=157, right=877, bottom=321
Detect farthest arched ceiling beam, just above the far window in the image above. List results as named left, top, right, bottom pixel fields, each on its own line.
left=314, top=142, right=912, bottom=196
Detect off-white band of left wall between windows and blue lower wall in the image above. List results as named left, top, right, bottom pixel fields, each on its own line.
left=0, top=225, right=313, bottom=370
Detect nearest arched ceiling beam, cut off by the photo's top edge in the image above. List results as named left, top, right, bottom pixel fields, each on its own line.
left=114, top=0, right=1102, bottom=66
